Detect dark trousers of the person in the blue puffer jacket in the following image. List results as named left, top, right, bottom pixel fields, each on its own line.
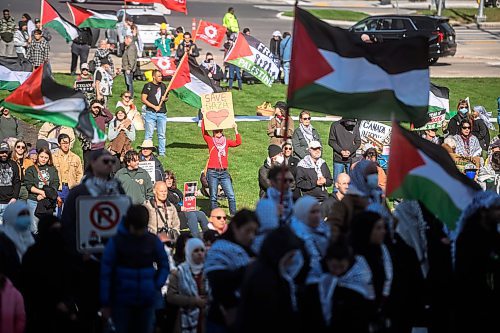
left=112, top=305, right=155, bottom=333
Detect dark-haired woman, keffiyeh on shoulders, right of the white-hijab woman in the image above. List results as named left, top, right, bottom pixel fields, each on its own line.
left=205, top=209, right=259, bottom=333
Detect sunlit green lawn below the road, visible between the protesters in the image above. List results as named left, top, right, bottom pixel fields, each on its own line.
left=0, top=74, right=500, bottom=208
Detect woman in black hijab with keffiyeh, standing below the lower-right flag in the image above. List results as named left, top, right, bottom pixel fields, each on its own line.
left=349, top=212, right=393, bottom=332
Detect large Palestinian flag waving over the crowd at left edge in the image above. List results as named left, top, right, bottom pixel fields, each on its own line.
left=0, top=64, right=106, bottom=142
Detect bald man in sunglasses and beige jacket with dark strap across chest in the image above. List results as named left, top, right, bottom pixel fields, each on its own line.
left=145, top=181, right=181, bottom=243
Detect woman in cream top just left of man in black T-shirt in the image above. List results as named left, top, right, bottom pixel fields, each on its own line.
left=108, top=107, right=135, bottom=162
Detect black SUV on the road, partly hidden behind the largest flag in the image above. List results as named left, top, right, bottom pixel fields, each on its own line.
left=349, top=15, right=457, bottom=64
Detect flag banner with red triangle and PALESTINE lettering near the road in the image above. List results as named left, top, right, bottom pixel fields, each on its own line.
left=224, top=33, right=280, bottom=87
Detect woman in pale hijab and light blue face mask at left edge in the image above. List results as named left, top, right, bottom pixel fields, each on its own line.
left=0, top=200, right=35, bottom=287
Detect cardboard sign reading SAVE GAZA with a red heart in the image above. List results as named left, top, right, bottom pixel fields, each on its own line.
left=201, top=92, right=234, bottom=131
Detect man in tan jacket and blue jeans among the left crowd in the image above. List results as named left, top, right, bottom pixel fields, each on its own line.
left=52, top=133, right=83, bottom=217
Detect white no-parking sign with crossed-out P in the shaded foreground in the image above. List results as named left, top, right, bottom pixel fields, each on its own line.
left=76, top=195, right=131, bottom=253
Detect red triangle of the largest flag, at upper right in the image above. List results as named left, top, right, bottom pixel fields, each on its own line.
left=288, top=10, right=335, bottom=94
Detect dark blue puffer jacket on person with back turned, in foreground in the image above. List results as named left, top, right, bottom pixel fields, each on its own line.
left=101, top=223, right=170, bottom=307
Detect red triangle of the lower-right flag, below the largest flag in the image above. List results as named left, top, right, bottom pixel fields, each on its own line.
left=386, top=122, right=425, bottom=196
